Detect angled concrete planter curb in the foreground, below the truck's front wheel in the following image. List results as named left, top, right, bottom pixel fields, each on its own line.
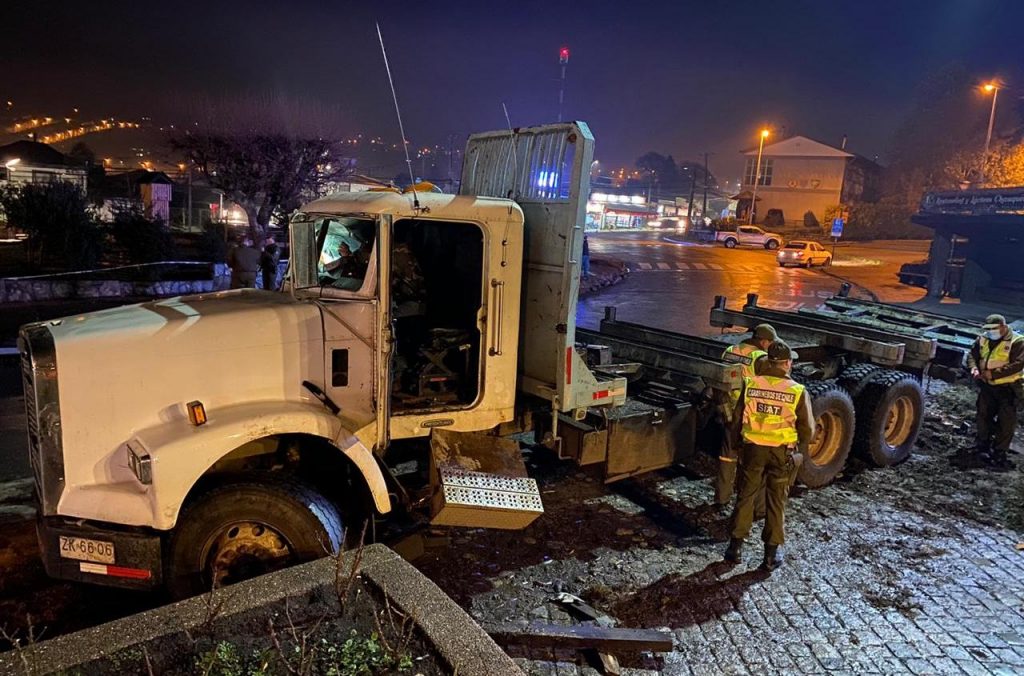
left=0, top=545, right=522, bottom=676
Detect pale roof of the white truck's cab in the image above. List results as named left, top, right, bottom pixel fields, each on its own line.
left=302, top=191, right=522, bottom=221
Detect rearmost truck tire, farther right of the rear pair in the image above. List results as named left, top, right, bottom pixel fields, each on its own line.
left=854, top=370, right=925, bottom=467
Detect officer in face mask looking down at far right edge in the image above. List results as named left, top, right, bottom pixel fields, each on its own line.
left=953, top=314, right=1024, bottom=471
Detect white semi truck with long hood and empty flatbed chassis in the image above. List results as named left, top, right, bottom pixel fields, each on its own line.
left=19, top=123, right=974, bottom=596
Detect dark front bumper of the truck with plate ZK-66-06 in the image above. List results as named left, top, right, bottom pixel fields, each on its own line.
left=36, top=516, right=163, bottom=590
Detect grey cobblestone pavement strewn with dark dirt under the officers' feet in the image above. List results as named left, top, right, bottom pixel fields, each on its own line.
left=420, top=388, right=1024, bottom=674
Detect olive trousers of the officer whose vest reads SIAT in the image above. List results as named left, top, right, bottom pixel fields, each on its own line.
left=732, top=443, right=794, bottom=545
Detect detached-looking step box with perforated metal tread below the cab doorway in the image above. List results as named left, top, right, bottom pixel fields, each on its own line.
left=430, top=429, right=544, bottom=530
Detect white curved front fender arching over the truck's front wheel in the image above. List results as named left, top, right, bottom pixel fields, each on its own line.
left=58, top=402, right=391, bottom=531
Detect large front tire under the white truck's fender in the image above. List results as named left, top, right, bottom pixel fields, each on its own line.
left=166, top=477, right=345, bottom=598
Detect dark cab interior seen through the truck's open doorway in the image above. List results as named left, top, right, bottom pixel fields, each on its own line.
left=391, top=218, right=483, bottom=413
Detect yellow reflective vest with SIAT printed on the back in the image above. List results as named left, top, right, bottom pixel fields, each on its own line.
left=742, top=376, right=804, bottom=446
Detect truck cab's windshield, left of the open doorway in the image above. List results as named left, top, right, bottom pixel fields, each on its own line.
left=291, top=216, right=377, bottom=291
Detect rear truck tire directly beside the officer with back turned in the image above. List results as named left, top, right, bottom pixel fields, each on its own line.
left=797, top=380, right=856, bottom=489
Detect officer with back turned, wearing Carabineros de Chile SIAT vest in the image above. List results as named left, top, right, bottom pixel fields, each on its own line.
left=725, top=340, right=814, bottom=572
